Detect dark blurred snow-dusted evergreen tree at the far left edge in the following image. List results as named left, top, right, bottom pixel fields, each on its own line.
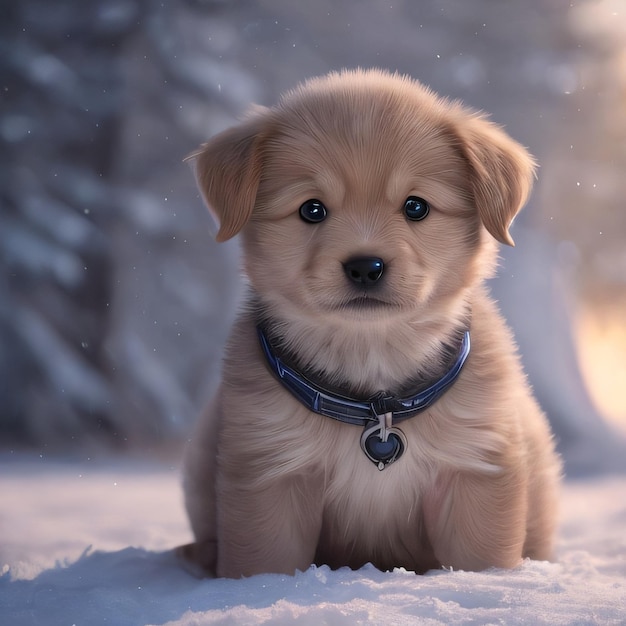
left=0, top=0, right=139, bottom=444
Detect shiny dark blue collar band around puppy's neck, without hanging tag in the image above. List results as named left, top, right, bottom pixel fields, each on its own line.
left=257, top=325, right=470, bottom=426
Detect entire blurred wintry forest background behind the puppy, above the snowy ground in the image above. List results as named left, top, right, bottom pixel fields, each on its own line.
left=0, top=0, right=626, bottom=475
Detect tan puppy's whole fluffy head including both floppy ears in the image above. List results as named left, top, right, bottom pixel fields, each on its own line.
left=192, top=71, right=534, bottom=319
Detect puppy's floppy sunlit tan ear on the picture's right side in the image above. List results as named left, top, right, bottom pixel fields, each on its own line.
left=456, top=115, right=535, bottom=246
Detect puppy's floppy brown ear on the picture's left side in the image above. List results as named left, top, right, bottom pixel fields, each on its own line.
left=185, top=107, right=268, bottom=241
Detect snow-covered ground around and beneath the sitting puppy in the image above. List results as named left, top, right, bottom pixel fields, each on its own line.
left=0, top=457, right=626, bottom=626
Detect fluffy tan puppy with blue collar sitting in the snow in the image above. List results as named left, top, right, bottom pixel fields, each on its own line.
left=179, top=70, right=560, bottom=577
